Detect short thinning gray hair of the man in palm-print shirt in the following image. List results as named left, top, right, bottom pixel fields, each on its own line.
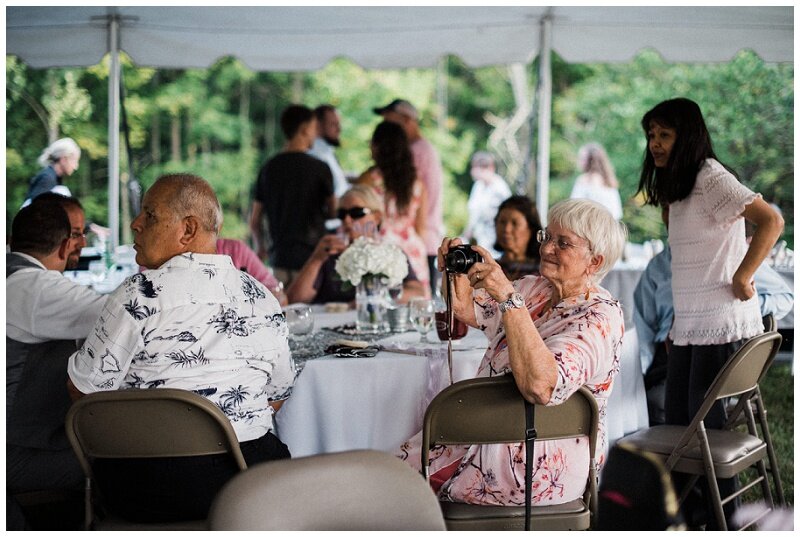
left=151, top=173, right=222, bottom=234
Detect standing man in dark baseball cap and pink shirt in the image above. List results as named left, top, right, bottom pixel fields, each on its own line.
left=372, top=99, right=444, bottom=291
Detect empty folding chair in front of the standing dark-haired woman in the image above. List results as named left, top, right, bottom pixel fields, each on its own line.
left=621, top=332, right=783, bottom=530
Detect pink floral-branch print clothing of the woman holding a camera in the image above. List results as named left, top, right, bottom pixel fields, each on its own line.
left=397, top=276, right=624, bottom=505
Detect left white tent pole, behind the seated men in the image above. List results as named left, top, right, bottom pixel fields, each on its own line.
left=108, top=14, right=120, bottom=252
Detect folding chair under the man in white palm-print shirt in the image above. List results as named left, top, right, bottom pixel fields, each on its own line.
left=66, top=389, right=247, bottom=530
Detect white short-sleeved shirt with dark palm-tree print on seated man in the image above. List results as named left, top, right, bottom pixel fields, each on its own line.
left=68, top=253, right=294, bottom=442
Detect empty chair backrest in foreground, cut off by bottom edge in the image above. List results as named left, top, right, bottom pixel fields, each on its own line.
left=209, top=450, right=445, bottom=531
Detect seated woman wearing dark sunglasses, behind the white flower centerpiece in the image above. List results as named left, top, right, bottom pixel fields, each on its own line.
left=286, top=185, right=426, bottom=303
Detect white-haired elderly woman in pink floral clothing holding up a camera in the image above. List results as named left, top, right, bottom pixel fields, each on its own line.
left=398, top=199, right=626, bottom=505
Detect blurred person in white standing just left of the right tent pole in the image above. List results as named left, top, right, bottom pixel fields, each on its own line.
left=463, top=151, right=511, bottom=259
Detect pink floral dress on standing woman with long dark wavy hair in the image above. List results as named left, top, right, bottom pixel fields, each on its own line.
left=372, top=171, right=431, bottom=298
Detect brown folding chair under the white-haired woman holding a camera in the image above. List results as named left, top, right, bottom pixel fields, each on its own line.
left=421, top=375, right=599, bottom=530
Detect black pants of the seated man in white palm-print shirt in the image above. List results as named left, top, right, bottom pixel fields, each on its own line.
left=93, top=433, right=290, bottom=522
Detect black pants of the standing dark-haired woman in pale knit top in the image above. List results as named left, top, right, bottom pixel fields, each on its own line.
left=664, top=340, right=744, bottom=529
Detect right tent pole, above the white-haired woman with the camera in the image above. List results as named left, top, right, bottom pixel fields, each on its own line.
left=536, top=14, right=553, bottom=226
